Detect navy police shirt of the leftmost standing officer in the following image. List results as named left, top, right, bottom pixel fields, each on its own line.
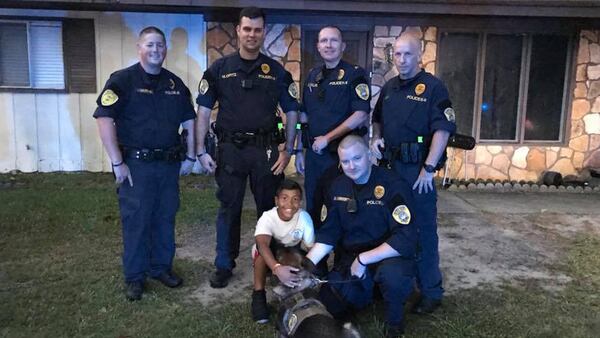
left=94, top=63, right=196, bottom=149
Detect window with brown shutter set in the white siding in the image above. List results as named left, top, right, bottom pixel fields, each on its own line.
left=0, top=19, right=96, bottom=92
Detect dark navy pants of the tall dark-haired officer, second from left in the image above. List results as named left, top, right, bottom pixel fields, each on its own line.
left=215, top=143, right=283, bottom=270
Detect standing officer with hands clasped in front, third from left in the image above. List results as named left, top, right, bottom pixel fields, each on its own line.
left=295, top=26, right=371, bottom=232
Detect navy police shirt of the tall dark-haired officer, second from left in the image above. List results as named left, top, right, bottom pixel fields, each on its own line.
left=196, top=52, right=299, bottom=132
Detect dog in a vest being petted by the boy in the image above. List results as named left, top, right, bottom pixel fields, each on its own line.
left=273, top=248, right=360, bottom=338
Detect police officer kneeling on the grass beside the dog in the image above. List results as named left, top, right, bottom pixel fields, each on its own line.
left=283, top=135, right=416, bottom=337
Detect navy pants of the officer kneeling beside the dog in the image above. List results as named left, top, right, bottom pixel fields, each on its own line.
left=319, top=257, right=414, bottom=326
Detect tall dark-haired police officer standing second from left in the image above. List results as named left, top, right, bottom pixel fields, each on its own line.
left=196, top=7, right=299, bottom=288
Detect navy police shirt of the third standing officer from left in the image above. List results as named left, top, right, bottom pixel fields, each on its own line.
left=302, top=60, right=371, bottom=138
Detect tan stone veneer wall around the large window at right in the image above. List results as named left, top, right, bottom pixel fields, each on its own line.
left=371, top=26, right=600, bottom=181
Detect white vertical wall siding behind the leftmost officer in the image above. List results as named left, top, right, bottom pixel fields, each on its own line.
left=0, top=8, right=206, bottom=172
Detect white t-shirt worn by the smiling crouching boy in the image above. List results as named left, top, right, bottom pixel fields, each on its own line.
left=254, top=207, right=315, bottom=248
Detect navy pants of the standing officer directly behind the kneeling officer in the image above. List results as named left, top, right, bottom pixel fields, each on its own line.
left=304, top=148, right=339, bottom=229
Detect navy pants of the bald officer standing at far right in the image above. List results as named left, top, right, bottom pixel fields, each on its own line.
left=393, top=161, right=444, bottom=299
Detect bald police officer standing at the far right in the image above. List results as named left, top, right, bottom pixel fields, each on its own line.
left=371, top=34, right=456, bottom=313
